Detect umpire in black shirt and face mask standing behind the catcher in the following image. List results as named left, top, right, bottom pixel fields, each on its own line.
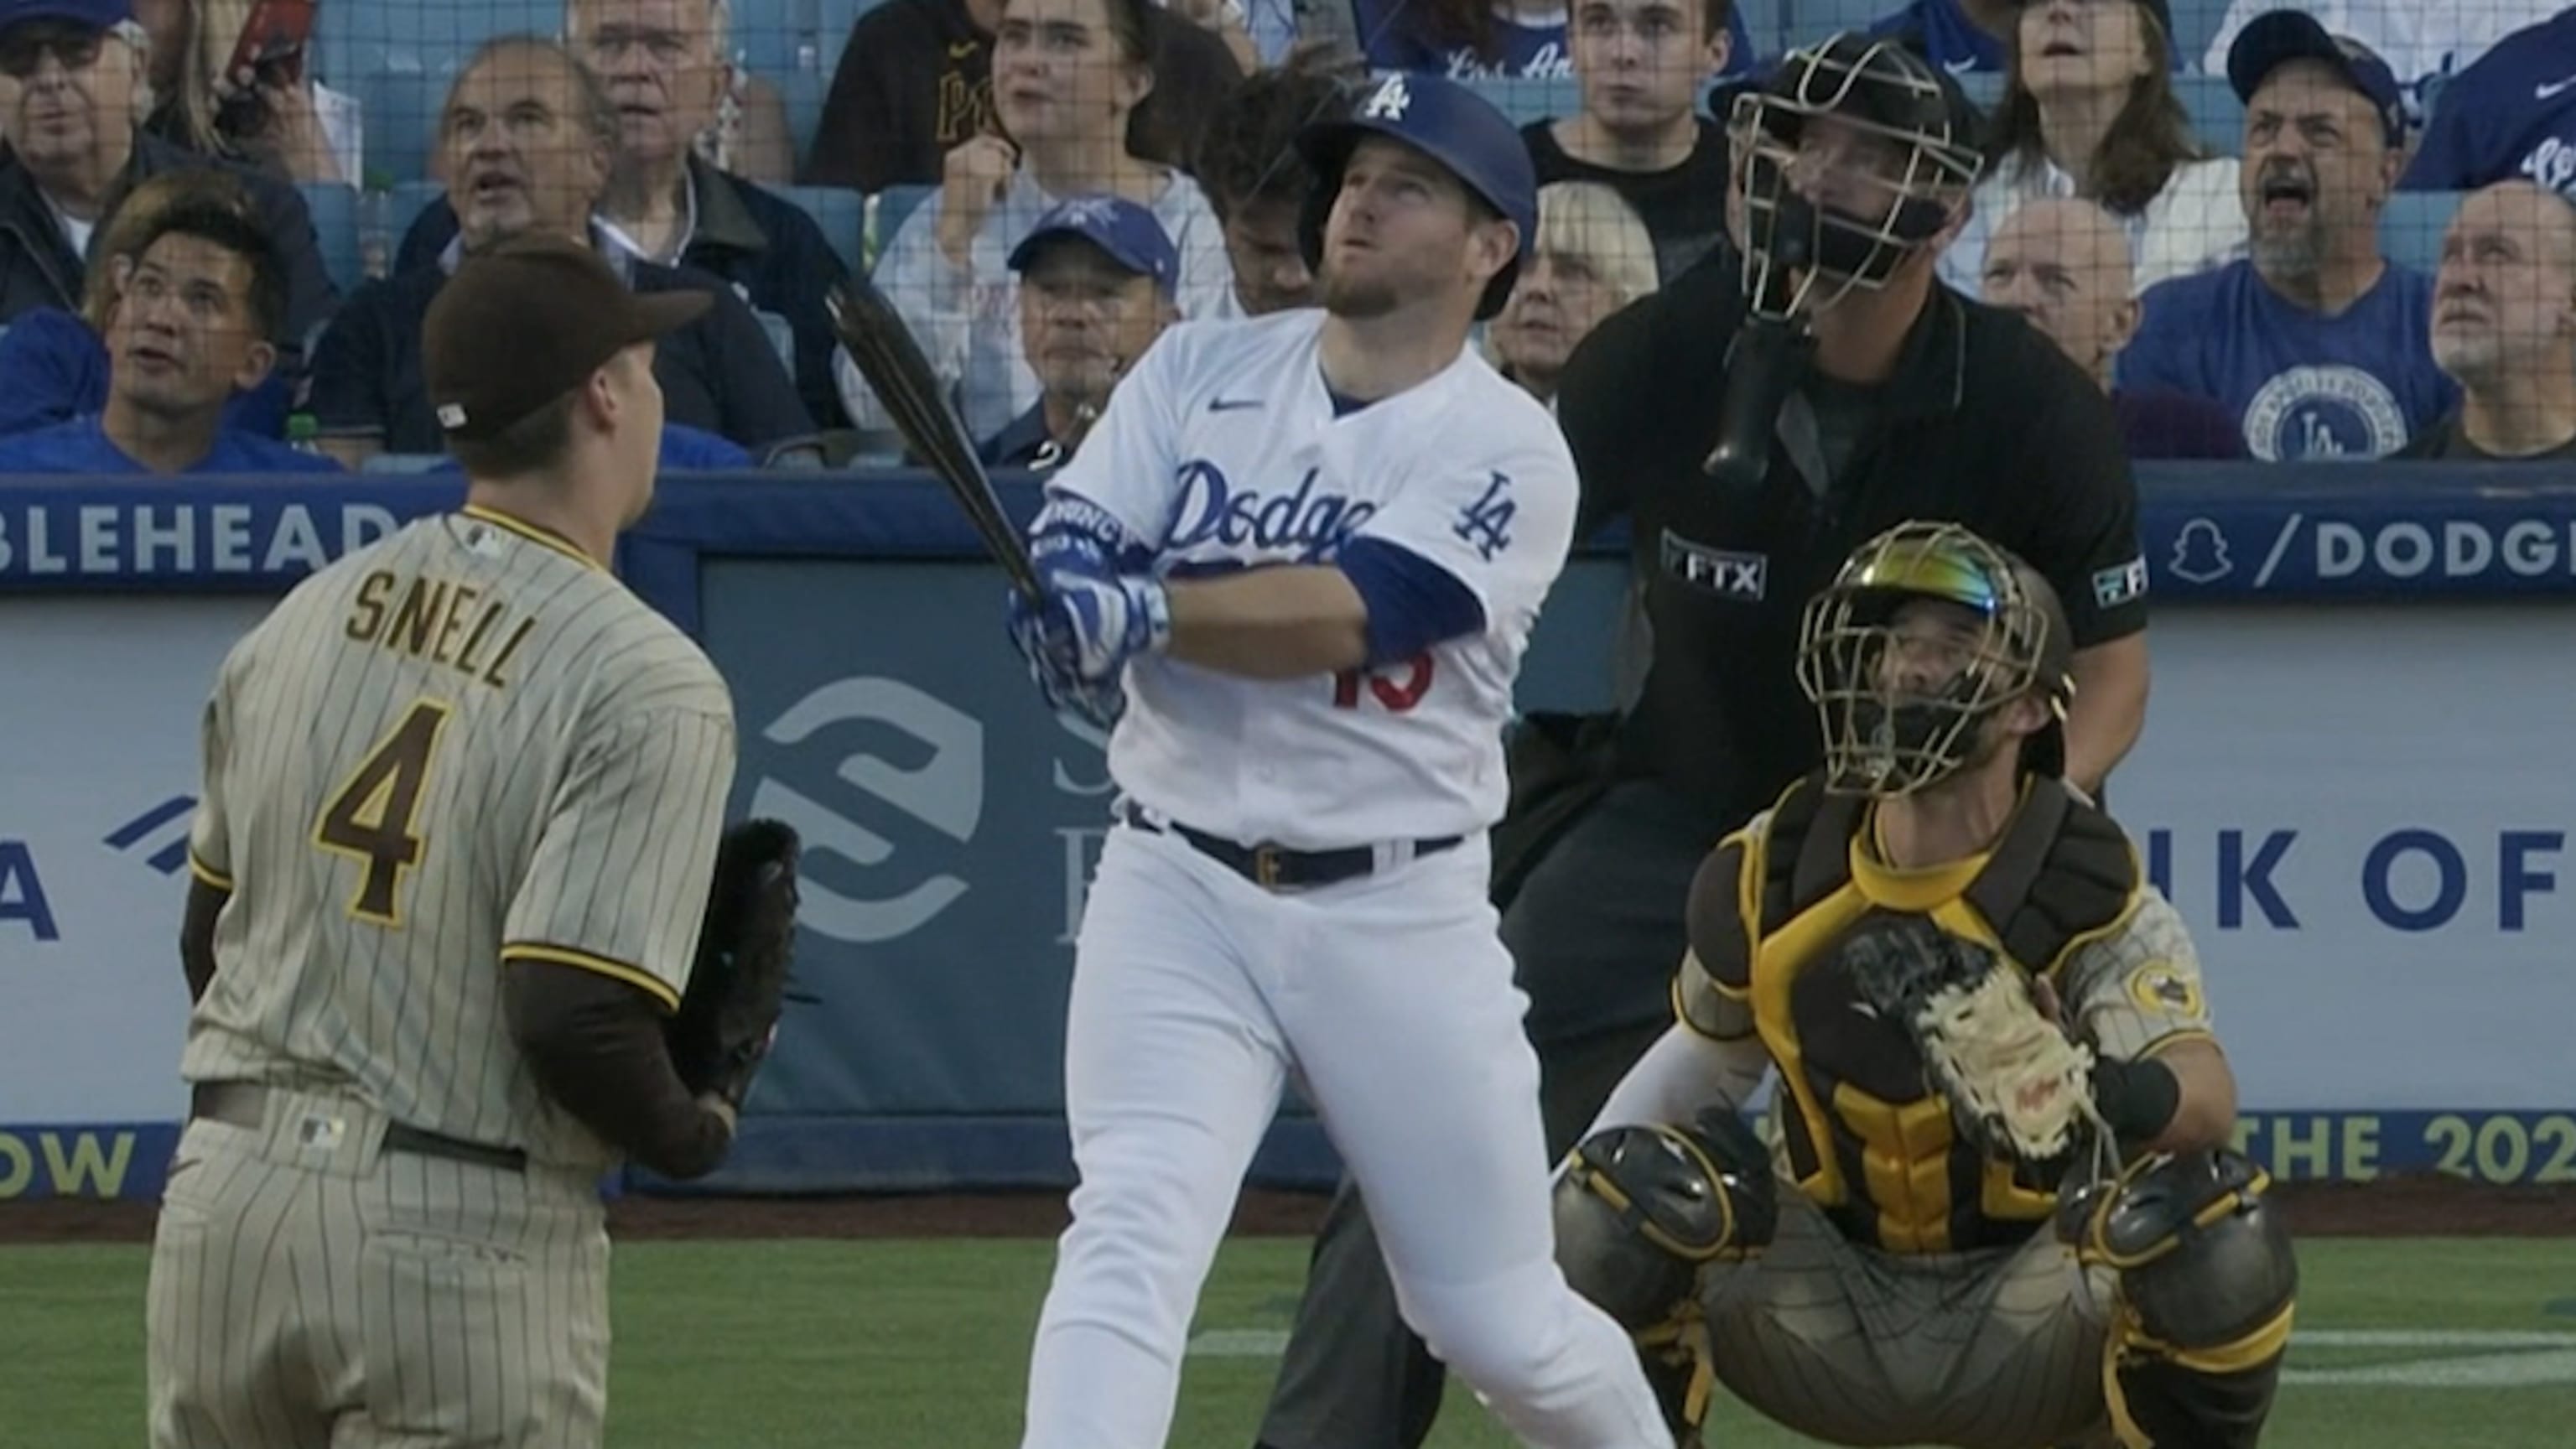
left=1262, top=34, right=2146, bottom=1449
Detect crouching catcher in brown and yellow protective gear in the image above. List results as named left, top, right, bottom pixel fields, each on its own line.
left=1555, top=523, right=2298, bottom=1449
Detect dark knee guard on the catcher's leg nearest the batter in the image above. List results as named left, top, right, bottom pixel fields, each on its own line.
left=1555, top=1111, right=1780, bottom=1333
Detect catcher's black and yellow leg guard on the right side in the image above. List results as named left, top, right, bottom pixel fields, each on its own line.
left=2069, top=1152, right=2298, bottom=1449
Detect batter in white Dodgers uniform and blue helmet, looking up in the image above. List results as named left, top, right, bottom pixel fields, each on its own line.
left=1012, top=75, right=1667, bottom=1449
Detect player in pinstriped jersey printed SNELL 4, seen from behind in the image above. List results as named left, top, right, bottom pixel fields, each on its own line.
left=147, top=240, right=788, bottom=1449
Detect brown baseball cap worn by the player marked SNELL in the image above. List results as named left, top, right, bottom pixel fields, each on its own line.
left=420, top=237, right=716, bottom=441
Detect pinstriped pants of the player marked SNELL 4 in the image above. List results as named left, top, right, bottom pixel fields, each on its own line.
left=147, top=1091, right=608, bottom=1449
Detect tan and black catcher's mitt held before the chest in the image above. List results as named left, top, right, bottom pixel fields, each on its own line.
left=1845, top=916, right=2100, bottom=1163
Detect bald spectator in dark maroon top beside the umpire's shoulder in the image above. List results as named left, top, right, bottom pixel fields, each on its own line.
left=1983, top=196, right=2246, bottom=459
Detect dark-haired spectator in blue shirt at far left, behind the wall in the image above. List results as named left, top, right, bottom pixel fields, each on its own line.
left=0, top=201, right=340, bottom=475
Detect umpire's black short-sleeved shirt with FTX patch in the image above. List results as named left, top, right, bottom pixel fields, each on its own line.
left=1555, top=247, right=2146, bottom=830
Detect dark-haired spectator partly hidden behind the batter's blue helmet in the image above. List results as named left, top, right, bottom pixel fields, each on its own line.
left=1190, top=46, right=1350, bottom=317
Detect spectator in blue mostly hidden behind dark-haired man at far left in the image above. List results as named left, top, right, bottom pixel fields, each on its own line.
left=0, top=168, right=288, bottom=439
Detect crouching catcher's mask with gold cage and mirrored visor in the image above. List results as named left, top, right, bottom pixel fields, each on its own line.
left=1798, top=523, right=2076, bottom=797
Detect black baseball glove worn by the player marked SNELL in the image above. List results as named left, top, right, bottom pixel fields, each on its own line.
left=665, top=820, right=796, bottom=1109
